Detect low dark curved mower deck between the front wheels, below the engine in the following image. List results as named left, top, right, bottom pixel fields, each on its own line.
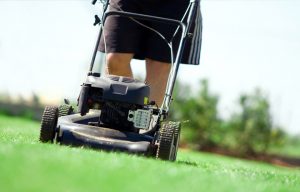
left=56, top=112, right=153, bottom=154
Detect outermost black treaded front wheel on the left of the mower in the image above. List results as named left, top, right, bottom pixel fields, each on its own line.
left=40, top=106, right=58, bottom=143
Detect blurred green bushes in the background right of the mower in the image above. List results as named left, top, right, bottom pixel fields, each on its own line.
left=170, top=80, right=287, bottom=155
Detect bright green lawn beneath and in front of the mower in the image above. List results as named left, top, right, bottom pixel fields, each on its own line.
left=0, top=116, right=300, bottom=192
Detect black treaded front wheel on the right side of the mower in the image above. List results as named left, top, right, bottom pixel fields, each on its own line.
left=156, top=122, right=177, bottom=161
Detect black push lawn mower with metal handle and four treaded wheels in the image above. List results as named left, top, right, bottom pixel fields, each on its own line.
left=40, top=0, right=199, bottom=161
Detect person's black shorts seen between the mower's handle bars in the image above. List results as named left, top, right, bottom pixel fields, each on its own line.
left=99, top=0, right=190, bottom=62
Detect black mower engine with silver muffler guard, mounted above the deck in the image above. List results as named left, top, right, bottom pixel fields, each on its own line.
left=78, top=73, right=153, bottom=131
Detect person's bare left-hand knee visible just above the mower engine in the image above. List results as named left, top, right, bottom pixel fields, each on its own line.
left=106, top=53, right=133, bottom=78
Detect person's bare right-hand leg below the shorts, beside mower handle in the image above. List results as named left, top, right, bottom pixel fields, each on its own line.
left=146, top=59, right=171, bottom=106
